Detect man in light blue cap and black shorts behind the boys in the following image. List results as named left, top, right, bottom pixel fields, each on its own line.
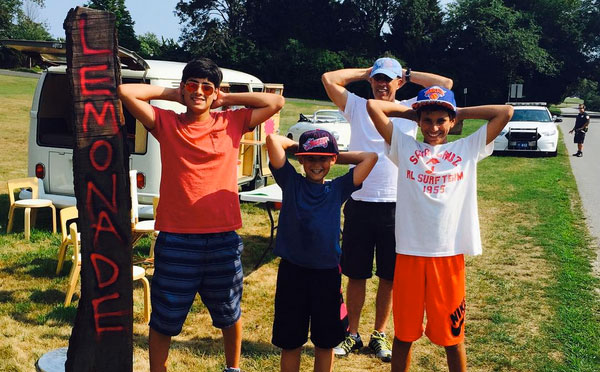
left=321, top=58, right=453, bottom=362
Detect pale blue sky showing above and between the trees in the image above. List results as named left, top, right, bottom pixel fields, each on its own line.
left=32, top=0, right=454, bottom=41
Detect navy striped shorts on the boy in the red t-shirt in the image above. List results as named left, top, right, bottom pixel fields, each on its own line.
left=150, top=231, right=244, bottom=336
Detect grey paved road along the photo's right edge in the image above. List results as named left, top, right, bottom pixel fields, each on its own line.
left=559, top=108, right=600, bottom=276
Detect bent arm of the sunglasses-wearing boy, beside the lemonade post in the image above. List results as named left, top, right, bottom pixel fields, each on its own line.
left=117, top=84, right=183, bottom=131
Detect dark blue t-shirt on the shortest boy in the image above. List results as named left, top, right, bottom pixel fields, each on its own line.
left=271, top=160, right=362, bottom=269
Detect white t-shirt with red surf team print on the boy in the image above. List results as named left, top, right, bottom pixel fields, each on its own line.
left=387, top=125, right=493, bottom=257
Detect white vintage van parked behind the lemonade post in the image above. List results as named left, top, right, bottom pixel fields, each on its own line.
left=0, top=40, right=283, bottom=218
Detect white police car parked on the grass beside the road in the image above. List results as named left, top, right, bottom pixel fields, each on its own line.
left=494, top=102, right=562, bottom=156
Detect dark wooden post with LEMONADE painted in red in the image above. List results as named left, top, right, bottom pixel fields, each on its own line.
left=63, top=7, right=133, bottom=372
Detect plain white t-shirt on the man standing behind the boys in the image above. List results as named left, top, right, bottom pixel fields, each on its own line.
left=342, top=92, right=417, bottom=202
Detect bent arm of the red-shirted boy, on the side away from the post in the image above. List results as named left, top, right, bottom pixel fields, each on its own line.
left=210, top=91, right=285, bottom=129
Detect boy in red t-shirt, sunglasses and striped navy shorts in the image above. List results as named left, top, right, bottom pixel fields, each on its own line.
left=118, top=58, right=284, bottom=372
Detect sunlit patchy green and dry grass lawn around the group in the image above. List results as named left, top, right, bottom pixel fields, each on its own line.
left=0, top=76, right=600, bottom=372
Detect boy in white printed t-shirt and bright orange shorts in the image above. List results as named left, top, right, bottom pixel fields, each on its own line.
left=367, top=86, right=513, bottom=371
